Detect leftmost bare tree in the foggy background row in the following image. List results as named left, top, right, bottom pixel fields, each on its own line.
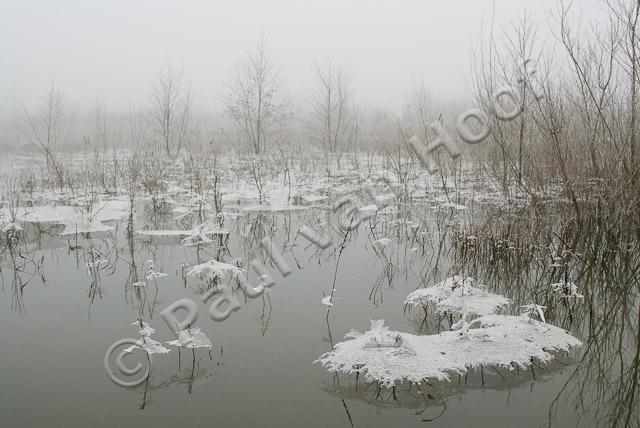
left=22, top=82, right=65, bottom=187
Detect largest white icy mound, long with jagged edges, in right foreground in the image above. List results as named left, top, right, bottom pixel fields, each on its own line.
left=316, top=315, right=582, bottom=387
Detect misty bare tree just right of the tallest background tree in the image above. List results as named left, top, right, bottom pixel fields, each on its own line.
left=311, top=58, right=356, bottom=163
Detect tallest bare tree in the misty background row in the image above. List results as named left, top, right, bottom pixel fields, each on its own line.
left=226, top=37, right=286, bottom=154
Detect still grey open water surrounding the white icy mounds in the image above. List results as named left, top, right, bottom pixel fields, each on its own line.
left=0, top=201, right=632, bottom=427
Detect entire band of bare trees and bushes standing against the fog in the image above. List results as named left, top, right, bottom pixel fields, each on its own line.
left=13, top=0, right=640, bottom=212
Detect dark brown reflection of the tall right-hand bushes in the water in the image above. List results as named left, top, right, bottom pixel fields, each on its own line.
left=396, top=204, right=640, bottom=426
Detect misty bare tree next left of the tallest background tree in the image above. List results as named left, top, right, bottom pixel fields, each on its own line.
left=149, top=64, right=191, bottom=156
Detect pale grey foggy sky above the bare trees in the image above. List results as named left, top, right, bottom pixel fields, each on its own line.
left=0, top=0, right=603, bottom=112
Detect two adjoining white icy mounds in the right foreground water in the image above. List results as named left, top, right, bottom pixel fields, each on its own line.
left=318, top=275, right=582, bottom=387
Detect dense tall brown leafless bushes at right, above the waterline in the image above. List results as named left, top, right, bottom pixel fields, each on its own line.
left=460, top=0, right=640, bottom=224
